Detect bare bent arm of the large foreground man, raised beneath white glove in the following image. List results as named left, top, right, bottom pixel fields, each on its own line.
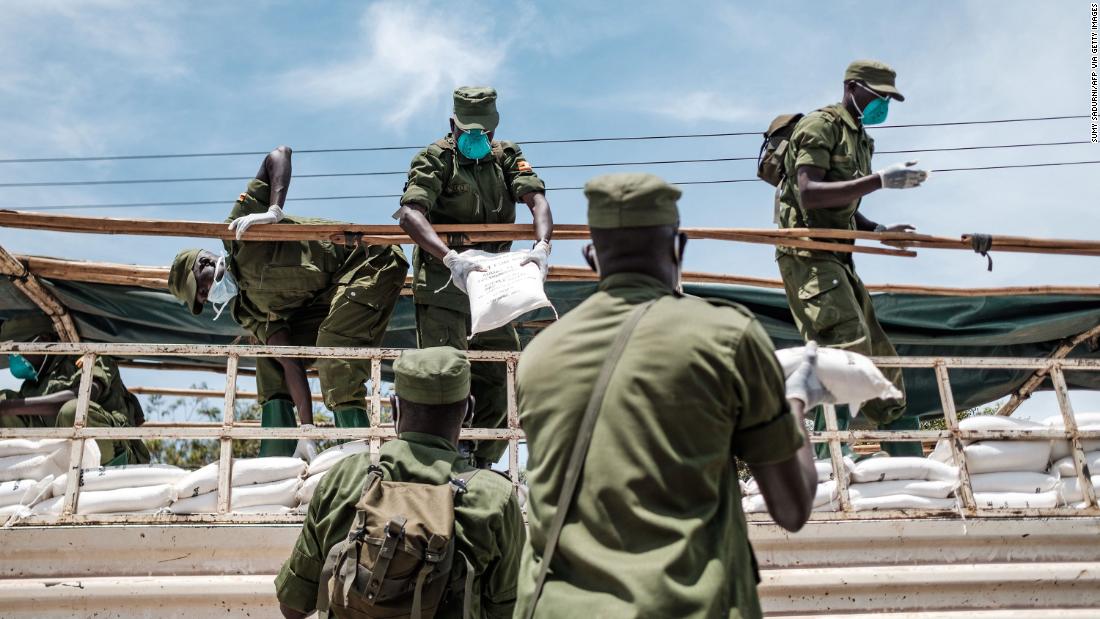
left=749, top=399, right=817, bottom=532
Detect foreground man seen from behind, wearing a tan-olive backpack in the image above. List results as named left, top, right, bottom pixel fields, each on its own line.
left=275, top=346, right=526, bottom=618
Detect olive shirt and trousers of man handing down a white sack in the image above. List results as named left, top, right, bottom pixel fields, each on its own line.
left=402, top=135, right=546, bottom=462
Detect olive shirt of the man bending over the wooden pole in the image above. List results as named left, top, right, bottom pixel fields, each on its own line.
left=224, top=179, right=388, bottom=345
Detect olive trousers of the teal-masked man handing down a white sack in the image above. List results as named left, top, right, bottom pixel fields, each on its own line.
left=416, top=303, right=519, bottom=464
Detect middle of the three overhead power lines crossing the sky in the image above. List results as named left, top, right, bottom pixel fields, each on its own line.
left=0, top=140, right=1091, bottom=188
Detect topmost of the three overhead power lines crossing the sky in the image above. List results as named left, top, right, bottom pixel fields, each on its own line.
left=0, top=114, right=1089, bottom=164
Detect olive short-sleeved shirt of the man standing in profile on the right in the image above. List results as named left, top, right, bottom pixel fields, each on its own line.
left=777, top=103, right=875, bottom=261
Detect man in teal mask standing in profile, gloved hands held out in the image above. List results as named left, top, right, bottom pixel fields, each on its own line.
left=776, top=60, right=927, bottom=456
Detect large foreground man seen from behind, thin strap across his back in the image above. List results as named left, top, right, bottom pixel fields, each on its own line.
left=516, top=174, right=823, bottom=618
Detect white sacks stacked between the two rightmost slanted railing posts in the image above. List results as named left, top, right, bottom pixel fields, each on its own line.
left=928, top=414, right=1059, bottom=509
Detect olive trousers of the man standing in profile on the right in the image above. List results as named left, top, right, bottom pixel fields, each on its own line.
left=777, top=254, right=921, bottom=455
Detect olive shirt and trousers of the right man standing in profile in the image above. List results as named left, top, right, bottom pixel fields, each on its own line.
left=776, top=103, right=920, bottom=455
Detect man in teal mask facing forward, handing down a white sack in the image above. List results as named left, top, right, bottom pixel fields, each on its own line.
left=394, top=87, right=553, bottom=466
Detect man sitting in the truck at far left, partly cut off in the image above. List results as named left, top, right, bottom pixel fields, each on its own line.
left=0, top=314, right=150, bottom=466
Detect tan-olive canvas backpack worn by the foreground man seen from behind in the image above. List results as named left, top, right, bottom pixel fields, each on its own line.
left=317, top=466, right=477, bottom=619
